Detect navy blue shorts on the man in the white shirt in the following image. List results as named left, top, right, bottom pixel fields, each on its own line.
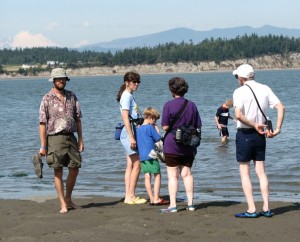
left=235, top=129, right=266, bottom=162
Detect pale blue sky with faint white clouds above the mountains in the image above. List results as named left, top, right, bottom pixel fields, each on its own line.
left=0, top=0, right=300, bottom=48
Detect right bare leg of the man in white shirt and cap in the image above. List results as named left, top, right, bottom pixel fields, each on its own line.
left=255, top=161, right=269, bottom=212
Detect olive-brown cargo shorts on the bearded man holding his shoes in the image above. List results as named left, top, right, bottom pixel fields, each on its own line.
left=47, top=133, right=82, bottom=169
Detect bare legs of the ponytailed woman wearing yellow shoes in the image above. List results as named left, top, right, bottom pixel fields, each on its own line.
left=124, top=154, right=141, bottom=203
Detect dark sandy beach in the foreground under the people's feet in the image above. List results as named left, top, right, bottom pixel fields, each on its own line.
left=0, top=197, right=300, bottom=242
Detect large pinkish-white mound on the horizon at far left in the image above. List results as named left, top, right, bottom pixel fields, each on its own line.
left=11, top=31, right=58, bottom=48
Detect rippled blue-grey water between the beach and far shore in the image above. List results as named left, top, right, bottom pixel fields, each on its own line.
left=0, top=70, right=300, bottom=202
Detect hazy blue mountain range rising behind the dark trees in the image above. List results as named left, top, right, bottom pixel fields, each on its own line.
left=77, top=25, right=300, bottom=52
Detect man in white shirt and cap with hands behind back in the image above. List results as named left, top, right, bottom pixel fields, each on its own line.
left=233, top=64, right=285, bottom=218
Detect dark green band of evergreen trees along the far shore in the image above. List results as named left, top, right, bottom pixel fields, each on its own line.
left=0, top=34, right=300, bottom=73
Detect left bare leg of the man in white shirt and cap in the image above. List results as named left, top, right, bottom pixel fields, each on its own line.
left=240, top=162, right=256, bottom=213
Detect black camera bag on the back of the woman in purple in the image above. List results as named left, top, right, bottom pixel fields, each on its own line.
left=175, top=125, right=201, bottom=147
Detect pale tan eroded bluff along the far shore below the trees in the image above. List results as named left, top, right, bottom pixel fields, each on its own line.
left=0, top=53, right=300, bottom=80
